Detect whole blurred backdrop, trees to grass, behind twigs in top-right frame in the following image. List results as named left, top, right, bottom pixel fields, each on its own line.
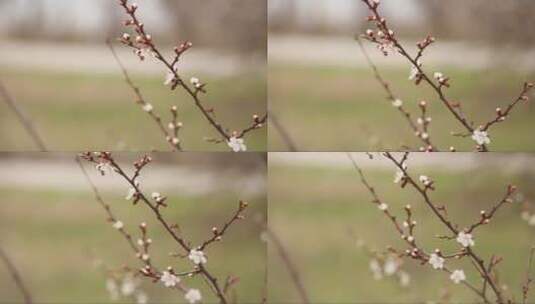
left=268, top=0, right=535, bottom=151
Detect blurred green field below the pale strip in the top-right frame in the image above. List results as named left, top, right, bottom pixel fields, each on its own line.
left=268, top=63, right=535, bottom=151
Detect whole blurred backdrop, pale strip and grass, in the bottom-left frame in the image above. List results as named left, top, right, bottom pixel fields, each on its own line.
left=0, top=153, right=267, bottom=303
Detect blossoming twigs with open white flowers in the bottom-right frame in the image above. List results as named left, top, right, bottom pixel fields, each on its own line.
left=348, top=152, right=532, bottom=303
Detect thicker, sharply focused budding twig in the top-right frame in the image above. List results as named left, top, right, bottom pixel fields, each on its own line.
left=362, top=0, right=533, bottom=152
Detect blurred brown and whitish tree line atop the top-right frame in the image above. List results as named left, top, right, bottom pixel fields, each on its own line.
left=269, top=0, right=535, bottom=45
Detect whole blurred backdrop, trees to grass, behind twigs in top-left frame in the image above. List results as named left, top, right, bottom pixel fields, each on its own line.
left=0, top=0, right=267, bottom=150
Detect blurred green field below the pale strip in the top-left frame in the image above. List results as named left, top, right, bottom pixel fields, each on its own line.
left=0, top=69, right=267, bottom=151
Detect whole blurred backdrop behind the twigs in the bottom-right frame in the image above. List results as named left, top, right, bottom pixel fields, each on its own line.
left=268, top=153, right=535, bottom=303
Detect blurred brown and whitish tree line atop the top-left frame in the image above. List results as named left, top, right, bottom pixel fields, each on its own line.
left=0, top=0, right=267, bottom=52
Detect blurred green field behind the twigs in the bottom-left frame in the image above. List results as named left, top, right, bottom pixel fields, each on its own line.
left=0, top=183, right=266, bottom=303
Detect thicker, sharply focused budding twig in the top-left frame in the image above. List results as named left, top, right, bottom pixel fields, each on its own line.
left=119, top=0, right=266, bottom=152
